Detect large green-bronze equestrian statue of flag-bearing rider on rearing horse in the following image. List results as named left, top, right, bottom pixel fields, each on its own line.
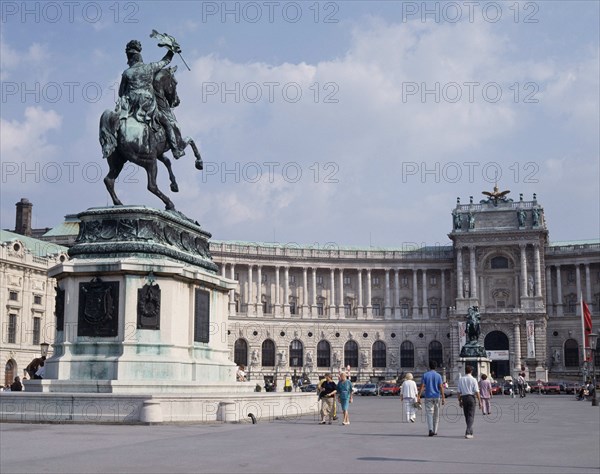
left=100, top=30, right=203, bottom=210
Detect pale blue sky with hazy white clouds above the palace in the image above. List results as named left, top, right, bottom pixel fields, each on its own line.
left=0, top=1, right=600, bottom=248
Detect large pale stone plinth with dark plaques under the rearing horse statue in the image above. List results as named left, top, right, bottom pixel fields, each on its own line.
left=44, top=206, right=241, bottom=394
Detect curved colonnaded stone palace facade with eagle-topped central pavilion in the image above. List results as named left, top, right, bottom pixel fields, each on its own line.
left=211, top=196, right=600, bottom=381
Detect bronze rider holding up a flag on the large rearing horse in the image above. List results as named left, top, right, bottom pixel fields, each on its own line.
left=117, top=37, right=186, bottom=158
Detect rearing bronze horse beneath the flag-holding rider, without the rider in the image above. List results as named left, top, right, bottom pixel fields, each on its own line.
left=100, top=66, right=203, bottom=210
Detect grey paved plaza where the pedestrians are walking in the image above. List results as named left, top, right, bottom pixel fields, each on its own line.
left=0, top=395, right=600, bottom=474
